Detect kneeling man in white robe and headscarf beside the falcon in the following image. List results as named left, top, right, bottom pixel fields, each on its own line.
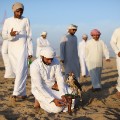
left=30, top=47, right=73, bottom=113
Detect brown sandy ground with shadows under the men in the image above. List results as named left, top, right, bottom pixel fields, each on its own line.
left=0, top=56, right=120, bottom=120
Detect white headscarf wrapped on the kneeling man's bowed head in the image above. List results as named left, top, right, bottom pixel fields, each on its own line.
left=40, top=46, right=56, bottom=58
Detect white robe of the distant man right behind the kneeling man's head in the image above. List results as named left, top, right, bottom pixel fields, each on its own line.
left=36, top=37, right=50, bottom=58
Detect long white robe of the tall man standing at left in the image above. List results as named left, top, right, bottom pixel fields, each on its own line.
left=2, top=17, right=33, bottom=96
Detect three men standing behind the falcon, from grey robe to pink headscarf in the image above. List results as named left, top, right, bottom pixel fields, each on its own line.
left=60, top=25, right=110, bottom=91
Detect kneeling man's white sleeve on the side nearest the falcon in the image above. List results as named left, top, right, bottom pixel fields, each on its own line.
left=55, top=64, right=67, bottom=96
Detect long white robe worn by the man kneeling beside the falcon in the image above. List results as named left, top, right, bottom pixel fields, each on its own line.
left=30, top=57, right=72, bottom=113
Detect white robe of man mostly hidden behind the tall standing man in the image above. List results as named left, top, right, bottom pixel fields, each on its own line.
left=2, top=40, right=15, bottom=78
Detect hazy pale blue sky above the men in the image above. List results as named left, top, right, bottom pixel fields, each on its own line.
left=0, top=0, right=120, bottom=55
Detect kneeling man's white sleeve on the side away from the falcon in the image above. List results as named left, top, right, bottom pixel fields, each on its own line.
left=30, top=64, right=54, bottom=102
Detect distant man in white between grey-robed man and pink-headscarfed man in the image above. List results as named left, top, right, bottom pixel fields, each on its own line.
left=78, top=34, right=88, bottom=77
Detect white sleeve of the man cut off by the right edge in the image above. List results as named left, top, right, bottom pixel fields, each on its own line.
left=110, top=31, right=120, bottom=54
